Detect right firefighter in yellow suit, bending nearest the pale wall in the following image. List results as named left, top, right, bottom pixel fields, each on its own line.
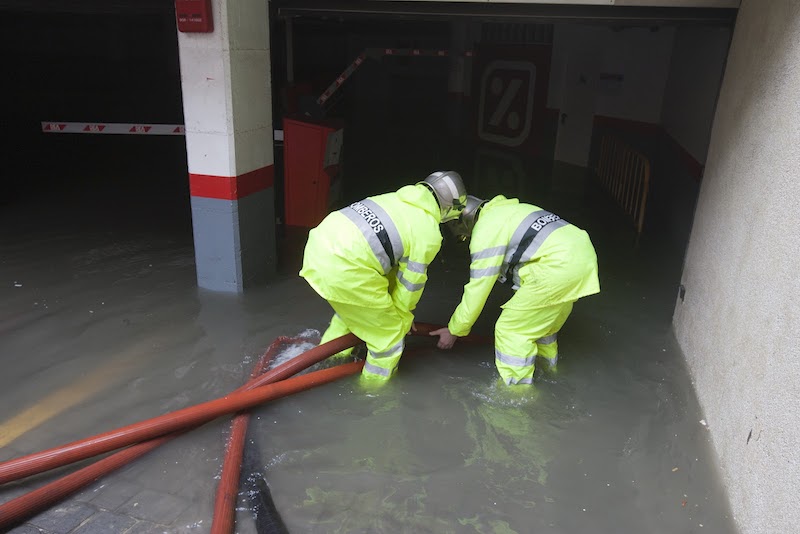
left=431, top=195, right=600, bottom=384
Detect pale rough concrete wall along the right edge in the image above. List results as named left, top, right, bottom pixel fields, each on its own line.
left=674, top=0, right=800, bottom=534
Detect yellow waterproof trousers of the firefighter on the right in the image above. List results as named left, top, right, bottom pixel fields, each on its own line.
left=494, top=302, right=574, bottom=384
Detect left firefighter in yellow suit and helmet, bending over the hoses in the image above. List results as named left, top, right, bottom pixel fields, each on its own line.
left=300, top=171, right=467, bottom=380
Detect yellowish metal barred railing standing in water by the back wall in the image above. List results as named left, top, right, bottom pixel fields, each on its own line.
left=595, top=135, right=650, bottom=241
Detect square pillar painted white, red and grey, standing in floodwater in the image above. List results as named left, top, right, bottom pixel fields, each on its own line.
left=178, top=0, right=276, bottom=292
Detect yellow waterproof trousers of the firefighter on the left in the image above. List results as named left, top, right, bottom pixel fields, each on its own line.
left=320, top=301, right=411, bottom=381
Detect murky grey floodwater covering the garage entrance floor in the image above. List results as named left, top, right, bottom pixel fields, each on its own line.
left=0, top=152, right=736, bottom=533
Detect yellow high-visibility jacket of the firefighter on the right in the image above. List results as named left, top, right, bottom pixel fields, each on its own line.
left=448, top=195, right=600, bottom=336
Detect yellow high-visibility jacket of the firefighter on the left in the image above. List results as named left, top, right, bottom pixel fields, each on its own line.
left=300, top=184, right=442, bottom=327
